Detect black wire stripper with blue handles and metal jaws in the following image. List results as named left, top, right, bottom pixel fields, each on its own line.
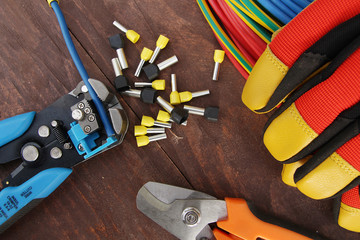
left=0, top=79, right=128, bottom=233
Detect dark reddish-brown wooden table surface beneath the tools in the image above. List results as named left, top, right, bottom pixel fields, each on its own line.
left=0, top=0, right=359, bottom=240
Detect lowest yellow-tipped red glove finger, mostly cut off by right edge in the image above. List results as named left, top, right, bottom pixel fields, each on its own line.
left=334, top=186, right=360, bottom=232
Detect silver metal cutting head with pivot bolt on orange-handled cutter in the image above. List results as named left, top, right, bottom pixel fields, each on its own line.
left=136, top=182, right=227, bottom=240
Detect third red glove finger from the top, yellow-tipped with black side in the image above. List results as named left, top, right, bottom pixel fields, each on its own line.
left=294, top=121, right=360, bottom=199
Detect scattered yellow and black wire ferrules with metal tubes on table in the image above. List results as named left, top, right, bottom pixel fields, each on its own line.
left=109, top=21, right=224, bottom=147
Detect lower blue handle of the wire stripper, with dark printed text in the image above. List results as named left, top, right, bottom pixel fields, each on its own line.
left=0, top=168, right=72, bottom=234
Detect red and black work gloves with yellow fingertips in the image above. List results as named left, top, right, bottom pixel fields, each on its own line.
left=242, top=0, right=360, bottom=232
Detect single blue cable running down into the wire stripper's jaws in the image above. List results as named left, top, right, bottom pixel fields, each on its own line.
left=51, top=1, right=115, bottom=137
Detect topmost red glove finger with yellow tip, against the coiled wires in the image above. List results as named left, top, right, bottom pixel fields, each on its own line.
left=242, top=0, right=360, bottom=113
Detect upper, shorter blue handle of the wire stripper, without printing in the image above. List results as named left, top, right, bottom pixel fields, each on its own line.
left=0, top=112, right=36, bottom=147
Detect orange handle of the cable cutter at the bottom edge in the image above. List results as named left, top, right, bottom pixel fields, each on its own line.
left=214, top=198, right=319, bottom=240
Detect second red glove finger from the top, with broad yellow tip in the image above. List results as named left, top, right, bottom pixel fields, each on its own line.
left=264, top=45, right=360, bottom=161
